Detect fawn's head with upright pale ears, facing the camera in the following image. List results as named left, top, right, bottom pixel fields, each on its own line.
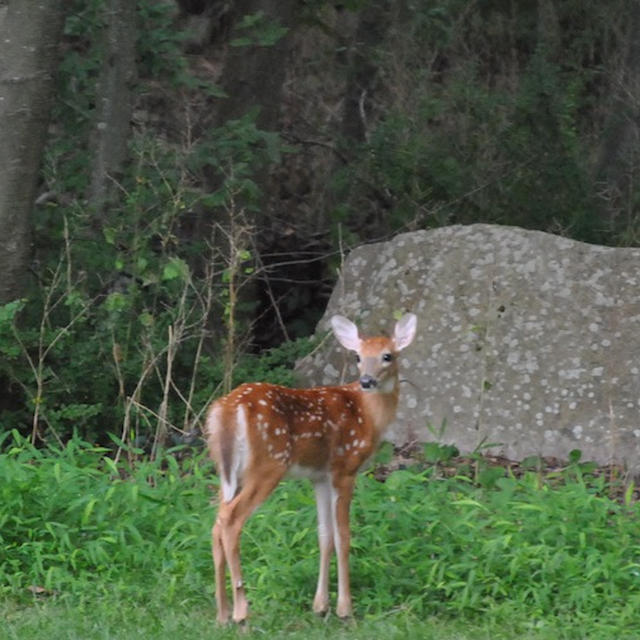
left=331, top=313, right=417, bottom=393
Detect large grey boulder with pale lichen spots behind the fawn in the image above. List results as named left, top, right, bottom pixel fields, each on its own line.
left=298, top=225, right=640, bottom=467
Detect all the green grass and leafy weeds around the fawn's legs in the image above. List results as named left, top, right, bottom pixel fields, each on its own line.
left=0, top=435, right=640, bottom=640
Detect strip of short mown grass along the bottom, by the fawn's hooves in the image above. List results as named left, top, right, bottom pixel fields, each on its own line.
left=0, top=600, right=568, bottom=640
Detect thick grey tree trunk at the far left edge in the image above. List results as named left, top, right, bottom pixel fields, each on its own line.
left=0, top=0, right=67, bottom=304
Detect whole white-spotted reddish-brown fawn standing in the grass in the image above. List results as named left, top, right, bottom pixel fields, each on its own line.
left=206, top=314, right=417, bottom=623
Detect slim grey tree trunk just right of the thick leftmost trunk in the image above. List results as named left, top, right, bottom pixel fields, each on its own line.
left=89, top=0, right=136, bottom=216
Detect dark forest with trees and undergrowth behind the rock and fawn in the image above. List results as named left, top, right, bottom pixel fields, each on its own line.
left=0, top=0, right=640, bottom=455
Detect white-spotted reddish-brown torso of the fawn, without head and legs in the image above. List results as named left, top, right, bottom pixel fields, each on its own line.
left=207, top=382, right=397, bottom=501
